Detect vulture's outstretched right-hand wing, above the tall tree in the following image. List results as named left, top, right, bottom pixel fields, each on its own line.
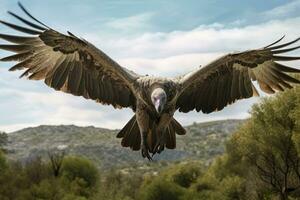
left=176, top=37, right=300, bottom=113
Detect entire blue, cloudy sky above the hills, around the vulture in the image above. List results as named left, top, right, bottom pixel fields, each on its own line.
left=0, top=0, right=300, bottom=132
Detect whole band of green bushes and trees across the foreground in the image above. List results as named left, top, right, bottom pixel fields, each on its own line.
left=0, top=85, right=300, bottom=200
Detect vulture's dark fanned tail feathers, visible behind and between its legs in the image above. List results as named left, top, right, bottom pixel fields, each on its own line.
left=117, top=115, right=186, bottom=154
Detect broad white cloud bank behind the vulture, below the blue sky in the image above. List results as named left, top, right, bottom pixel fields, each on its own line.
left=0, top=12, right=300, bottom=131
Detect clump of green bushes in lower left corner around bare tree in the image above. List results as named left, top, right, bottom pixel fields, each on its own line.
left=0, top=154, right=98, bottom=200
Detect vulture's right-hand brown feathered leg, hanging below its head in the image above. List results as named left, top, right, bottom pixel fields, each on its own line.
left=152, top=113, right=173, bottom=156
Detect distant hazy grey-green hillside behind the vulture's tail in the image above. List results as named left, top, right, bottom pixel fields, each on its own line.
left=6, top=120, right=244, bottom=169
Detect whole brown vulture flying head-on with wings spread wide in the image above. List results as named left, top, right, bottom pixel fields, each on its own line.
left=0, top=3, right=300, bottom=160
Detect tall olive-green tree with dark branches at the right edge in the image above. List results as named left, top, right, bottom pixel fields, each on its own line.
left=228, top=88, right=300, bottom=200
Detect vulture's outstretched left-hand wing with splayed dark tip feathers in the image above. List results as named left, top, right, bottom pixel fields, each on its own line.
left=0, top=4, right=139, bottom=108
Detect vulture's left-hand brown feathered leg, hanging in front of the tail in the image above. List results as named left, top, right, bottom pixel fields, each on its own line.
left=136, top=109, right=152, bottom=160
